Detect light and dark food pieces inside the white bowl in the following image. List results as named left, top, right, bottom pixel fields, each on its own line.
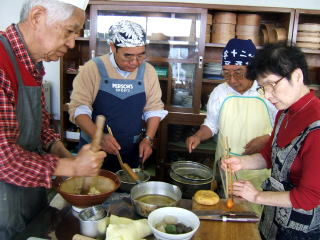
left=155, top=215, right=193, bottom=234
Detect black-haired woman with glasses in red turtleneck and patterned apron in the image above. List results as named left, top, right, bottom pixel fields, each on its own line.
left=222, top=44, right=320, bottom=240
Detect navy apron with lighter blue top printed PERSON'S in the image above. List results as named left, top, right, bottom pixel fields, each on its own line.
left=80, top=58, right=146, bottom=171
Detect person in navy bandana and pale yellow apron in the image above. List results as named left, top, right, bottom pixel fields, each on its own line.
left=186, top=39, right=276, bottom=212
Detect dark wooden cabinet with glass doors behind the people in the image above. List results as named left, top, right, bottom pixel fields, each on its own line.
left=61, top=1, right=320, bottom=180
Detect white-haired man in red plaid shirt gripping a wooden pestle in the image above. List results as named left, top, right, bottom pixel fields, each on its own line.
left=0, top=0, right=106, bottom=240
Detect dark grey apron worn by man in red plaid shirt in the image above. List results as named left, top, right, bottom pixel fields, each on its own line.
left=0, top=36, right=47, bottom=240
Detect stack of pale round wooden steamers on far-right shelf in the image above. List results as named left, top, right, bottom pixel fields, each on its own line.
left=296, top=23, right=320, bottom=49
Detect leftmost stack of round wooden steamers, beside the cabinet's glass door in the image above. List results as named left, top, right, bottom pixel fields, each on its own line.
left=211, top=12, right=237, bottom=44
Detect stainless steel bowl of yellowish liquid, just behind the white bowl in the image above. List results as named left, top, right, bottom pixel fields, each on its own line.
left=131, top=181, right=182, bottom=217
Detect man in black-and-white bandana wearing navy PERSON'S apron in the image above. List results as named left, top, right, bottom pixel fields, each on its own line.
left=69, top=20, right=167, bottom=171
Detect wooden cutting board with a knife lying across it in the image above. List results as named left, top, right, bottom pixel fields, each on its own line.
left=192, top=199, right=261, bottom=240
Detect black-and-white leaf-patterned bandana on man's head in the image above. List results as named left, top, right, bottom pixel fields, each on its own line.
left=108, top=20, right=146, bottom=47
